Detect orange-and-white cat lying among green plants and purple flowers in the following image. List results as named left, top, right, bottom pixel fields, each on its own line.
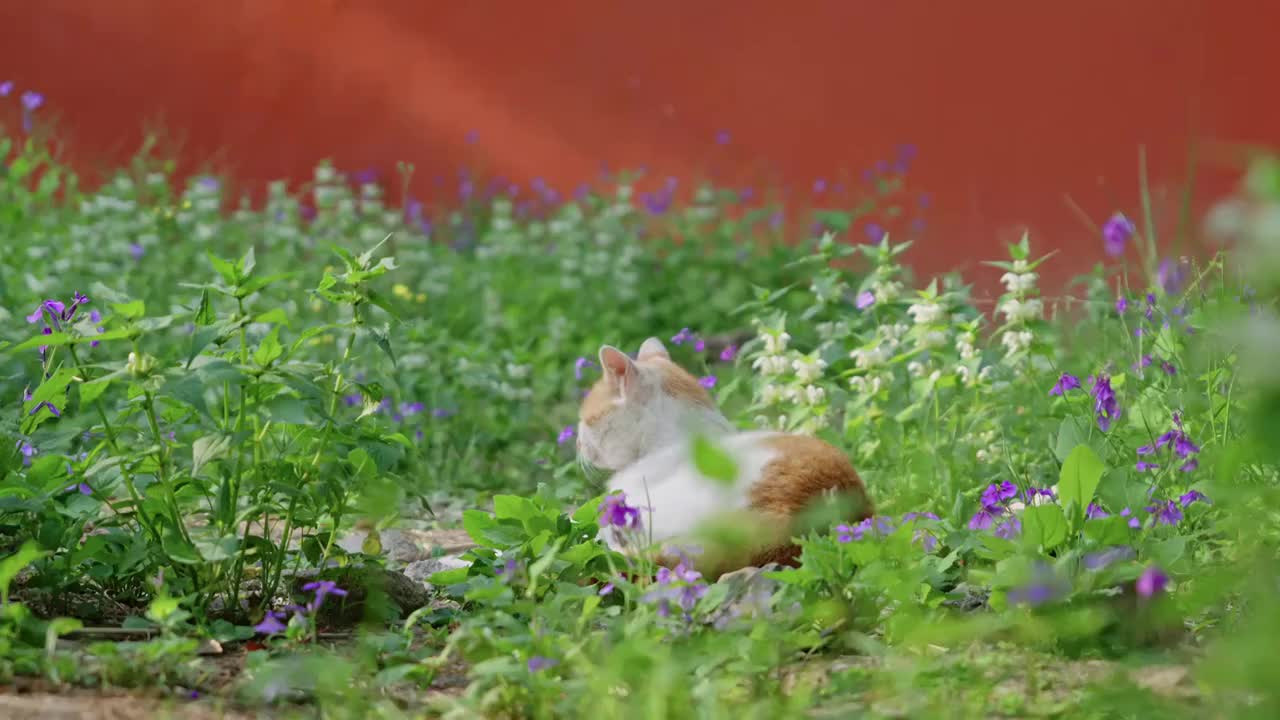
left=576, top=337, right=874, bottom=578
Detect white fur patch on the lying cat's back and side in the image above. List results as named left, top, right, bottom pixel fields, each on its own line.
left=602, top=430, right=780, bottom=551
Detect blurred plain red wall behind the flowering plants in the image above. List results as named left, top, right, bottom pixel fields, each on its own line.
left=0, top=0, right=1280, bottom=292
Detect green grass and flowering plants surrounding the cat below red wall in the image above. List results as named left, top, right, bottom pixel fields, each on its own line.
left=0, top=96, right=1280, bottom=717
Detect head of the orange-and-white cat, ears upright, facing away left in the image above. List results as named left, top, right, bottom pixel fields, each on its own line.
left=577, top=337, right=731, bottom=470
